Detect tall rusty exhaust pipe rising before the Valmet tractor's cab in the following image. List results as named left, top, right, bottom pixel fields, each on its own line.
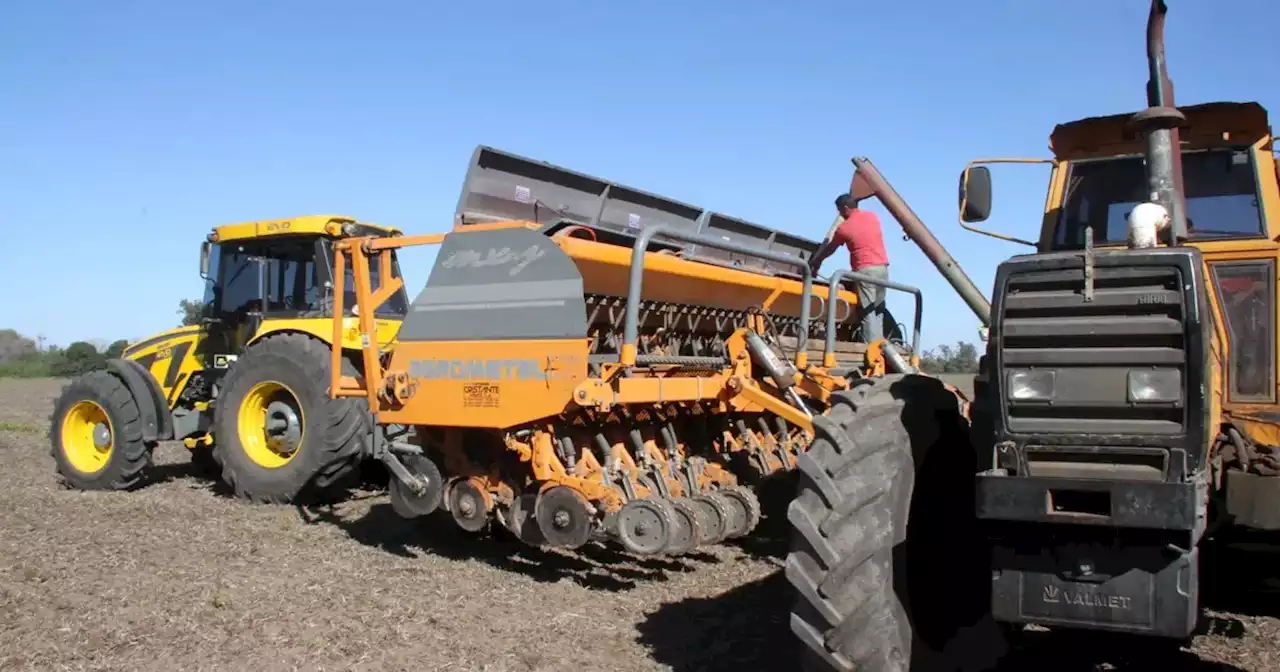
left=1132, top=0, right=1187, bottom=244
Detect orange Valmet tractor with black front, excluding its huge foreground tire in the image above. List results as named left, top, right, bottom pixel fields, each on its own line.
left=931, top=0, right=1280, bottom=655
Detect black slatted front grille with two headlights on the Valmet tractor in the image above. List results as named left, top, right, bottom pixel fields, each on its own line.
left=992, top=264, right=1188, bottom=435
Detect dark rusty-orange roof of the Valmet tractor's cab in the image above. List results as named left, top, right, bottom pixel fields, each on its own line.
left=1048, top=102, right=1271, bottom=159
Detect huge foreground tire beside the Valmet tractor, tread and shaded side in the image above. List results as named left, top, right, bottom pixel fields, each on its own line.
left=786, top=375, right=1004, bottom=672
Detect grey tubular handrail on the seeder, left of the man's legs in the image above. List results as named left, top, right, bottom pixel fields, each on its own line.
left=621, top=224, right=819, bottom=370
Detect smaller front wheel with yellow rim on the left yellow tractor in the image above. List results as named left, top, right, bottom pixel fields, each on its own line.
left=49, top=371, right=155, bottom=490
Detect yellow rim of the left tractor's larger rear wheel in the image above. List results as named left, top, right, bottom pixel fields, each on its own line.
left=237, top=380, right=305, bottom=468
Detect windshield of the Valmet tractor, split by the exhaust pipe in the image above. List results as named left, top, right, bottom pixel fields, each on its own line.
left=1052, top=148, right=1265, bottom=250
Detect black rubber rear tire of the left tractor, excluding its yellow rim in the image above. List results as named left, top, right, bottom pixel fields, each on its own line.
left=212, top=334, right=369, bottom=503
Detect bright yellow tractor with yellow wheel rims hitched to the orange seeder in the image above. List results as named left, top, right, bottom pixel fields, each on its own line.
left=50, top=215, right=408, bottom=502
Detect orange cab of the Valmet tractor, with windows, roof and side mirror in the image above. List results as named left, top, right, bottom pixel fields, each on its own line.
left=961, top=102, right=1280, bottom=435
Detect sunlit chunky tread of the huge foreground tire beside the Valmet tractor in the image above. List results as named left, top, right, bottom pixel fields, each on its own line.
left=785, top=375, right=957, bottom=672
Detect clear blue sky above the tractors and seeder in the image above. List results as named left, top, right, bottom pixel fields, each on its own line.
left=0, top=0, right=1280, bottom=347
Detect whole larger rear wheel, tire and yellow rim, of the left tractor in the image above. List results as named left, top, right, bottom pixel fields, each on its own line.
left=212, top=334, right=369, bottom=503
